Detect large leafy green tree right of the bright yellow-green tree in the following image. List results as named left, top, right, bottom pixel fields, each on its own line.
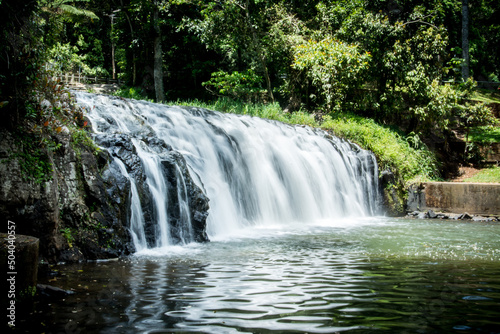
left=320, top=2, right=455, bottom=132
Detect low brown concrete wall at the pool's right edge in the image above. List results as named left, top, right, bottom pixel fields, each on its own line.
left=408, top=182, right=500, bottom=215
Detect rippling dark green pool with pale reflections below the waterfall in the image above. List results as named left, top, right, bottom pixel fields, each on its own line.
left=18, top=219, right=500, bottom=333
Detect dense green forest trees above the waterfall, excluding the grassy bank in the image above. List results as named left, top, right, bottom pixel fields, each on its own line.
left=0, top=0, right=500, bottom=163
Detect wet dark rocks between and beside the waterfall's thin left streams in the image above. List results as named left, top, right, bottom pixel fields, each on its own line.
left=95, top=134, right=209, bottom=246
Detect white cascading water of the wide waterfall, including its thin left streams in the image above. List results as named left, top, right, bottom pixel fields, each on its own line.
left=76, top=93, right=379, bottom=247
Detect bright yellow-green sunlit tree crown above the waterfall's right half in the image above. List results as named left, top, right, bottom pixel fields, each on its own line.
left=292, top=38, right=370, bottom=110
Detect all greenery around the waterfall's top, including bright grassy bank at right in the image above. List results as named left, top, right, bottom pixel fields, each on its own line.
left=0, top=0, right=500, bottom=219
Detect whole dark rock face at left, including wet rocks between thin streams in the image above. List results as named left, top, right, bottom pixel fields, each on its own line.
left=0, top=124, right=208, bottom=262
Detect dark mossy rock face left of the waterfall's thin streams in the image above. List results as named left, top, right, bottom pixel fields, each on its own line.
left=0, top=130, right=131, bottom=262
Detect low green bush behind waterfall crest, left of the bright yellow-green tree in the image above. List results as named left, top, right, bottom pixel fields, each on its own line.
left=202, top=69, right=262, bottom=101
